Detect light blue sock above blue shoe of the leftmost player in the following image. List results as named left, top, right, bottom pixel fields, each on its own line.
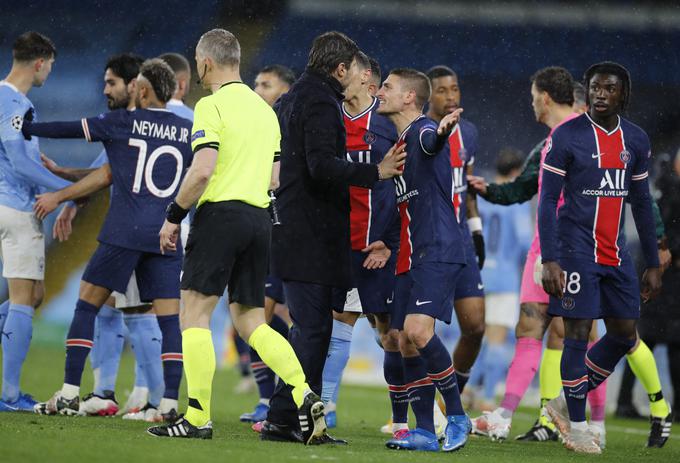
left=0, top=304, right=35, bottom=402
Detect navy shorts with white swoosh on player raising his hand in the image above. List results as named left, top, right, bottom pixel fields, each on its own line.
left=390, top=262, right=465, bottom=330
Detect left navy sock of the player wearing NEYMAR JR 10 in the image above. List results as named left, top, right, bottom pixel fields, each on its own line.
left=64, top=299, right=99, bottom=386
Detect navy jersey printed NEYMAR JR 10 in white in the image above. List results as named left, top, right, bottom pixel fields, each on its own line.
left=82, top=109, right=193, bottom=253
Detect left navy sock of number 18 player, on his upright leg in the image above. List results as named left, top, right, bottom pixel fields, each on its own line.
left=560, top=338, right=588, bottom=422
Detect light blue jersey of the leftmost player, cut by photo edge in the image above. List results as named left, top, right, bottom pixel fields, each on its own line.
left=0, top=81, right=71, bottom=212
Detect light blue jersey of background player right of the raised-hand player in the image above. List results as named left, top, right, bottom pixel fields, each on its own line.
left=478, top=197, right=533, bottom=293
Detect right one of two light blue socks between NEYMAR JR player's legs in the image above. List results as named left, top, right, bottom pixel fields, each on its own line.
left=125, top=314, right=165, bottom=407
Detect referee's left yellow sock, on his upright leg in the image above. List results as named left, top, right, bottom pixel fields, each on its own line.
left=182, top=328, right=215, bottom=426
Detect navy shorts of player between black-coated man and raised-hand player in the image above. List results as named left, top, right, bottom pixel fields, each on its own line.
left=352, top=251, right=397, bottom=313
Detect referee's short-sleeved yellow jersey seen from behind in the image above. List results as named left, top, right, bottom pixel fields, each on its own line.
left=191, top=82, right=281, bottom=208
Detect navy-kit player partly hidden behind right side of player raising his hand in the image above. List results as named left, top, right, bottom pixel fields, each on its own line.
left=427, top=66, right=485, bottom=398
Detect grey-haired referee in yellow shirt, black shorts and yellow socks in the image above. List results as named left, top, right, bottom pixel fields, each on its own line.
left=148, top=29, right=326, bottom=444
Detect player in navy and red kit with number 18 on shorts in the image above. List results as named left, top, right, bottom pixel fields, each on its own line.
left=538, top=62, right=671, bottom=453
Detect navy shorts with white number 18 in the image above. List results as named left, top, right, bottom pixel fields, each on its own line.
left=548, top=258, right=640, bottom=320
